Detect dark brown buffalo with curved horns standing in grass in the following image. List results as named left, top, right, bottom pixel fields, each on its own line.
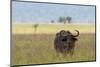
left=54, top=30, right=79, bottom=55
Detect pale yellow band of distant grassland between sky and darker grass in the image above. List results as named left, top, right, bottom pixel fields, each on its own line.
left=12, top=24, right=95, bottom=34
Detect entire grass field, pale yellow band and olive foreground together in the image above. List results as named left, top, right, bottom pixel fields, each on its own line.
left=12, top=24, right=96, bottom=65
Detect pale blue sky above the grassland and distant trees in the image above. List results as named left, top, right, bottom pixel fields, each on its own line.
left=12, top=1, right=95, bottom=23
